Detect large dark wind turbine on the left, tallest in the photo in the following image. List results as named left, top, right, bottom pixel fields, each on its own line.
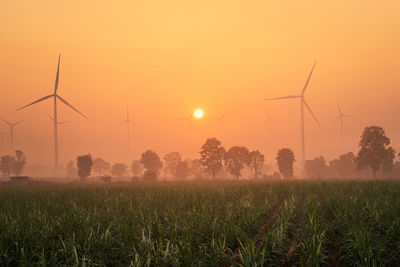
left=17, top=54, right=87, bottom=170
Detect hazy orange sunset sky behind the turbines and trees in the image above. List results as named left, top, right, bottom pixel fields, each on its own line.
left=0, top=0, right=400, bottom=174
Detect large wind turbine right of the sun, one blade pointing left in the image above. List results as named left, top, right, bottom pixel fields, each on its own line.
left=265, top=62, right=321, bottom=176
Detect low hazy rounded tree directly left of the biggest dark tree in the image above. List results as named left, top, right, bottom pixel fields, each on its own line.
left=329, top=152, right=357, bottom=178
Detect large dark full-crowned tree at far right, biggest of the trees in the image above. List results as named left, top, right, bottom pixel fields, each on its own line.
left=356, top=126, right=394, bottom=178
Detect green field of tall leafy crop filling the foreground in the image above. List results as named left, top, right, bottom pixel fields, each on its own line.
left=0, top=181, right=400, bottom=266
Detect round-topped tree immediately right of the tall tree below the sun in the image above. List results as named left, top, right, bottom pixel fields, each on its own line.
left=224, top=146, right=249, bottom=179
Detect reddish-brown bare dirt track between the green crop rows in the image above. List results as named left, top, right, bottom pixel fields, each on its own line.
left=225, top=198, right=283, bottom=267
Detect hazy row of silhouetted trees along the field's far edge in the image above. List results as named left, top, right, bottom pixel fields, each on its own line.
left=0, top=126, right=400, bottom=181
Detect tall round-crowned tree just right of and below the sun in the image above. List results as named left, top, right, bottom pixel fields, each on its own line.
left=200, top=138, right=225, bottom=180
